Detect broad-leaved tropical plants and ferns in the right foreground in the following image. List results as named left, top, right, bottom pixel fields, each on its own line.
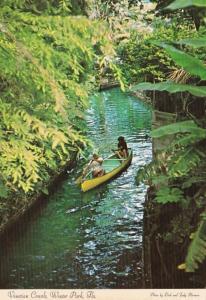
left=133, top=0, right=206, bottom=272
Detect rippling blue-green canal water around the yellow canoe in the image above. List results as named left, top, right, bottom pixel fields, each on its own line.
left=0, top=89, right=152, bottom=288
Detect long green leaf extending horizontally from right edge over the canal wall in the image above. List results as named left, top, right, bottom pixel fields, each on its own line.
left=132, top=82, right=206, bottom=97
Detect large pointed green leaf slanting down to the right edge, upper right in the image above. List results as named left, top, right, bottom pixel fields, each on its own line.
left=153, top=41, right=206, bottom=80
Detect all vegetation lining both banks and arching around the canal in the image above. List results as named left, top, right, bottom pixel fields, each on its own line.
left=0, top=0, right=206, bottom=288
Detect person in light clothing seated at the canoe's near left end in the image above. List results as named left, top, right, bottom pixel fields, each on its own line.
left=83, top=153, right=105, bottom=178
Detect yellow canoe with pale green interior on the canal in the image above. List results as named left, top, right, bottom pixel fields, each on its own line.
left=81, top=149, right=132, bottom=192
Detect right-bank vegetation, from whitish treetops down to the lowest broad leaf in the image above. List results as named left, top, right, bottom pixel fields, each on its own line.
left=81, top=0, right=206, bottom=271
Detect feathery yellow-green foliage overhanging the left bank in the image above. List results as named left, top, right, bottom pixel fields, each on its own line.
left=0, top=0, right=114, bottom=230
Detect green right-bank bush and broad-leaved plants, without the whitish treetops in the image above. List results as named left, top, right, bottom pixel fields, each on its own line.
left=126, top=1, right=206, bottom=272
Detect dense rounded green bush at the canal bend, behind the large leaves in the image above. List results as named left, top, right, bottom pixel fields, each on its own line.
left=118, top=20, right=200, bottom=83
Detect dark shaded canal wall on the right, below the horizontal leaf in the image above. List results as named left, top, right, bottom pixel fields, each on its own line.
left=143, top=92, right=205, bottom=289
